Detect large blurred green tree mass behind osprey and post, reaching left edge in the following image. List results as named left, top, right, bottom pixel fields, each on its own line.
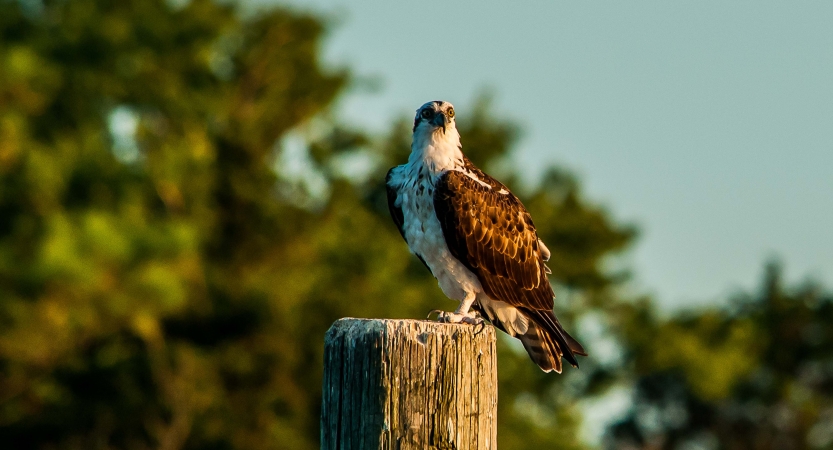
left=0, top=0, right=635, bottom=449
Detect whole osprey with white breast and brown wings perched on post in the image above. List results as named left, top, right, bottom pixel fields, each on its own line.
left=385, top=101, right=587, bottom=373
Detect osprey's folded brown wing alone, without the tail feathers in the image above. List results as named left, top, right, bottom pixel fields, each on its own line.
left=434, top=171, right=555, bottom=311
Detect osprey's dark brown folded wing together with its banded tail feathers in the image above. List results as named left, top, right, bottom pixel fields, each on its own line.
left=434, top=163, right=586, bottom=372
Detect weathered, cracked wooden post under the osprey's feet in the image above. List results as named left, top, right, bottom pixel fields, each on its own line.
left=321, top=318, right=497, bottom=450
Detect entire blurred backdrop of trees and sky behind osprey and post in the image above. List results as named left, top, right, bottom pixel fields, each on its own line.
left=0, top=0, right=833, bottom=450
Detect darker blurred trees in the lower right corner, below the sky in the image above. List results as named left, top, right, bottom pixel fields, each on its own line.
left=608, top=263, right=833, bottom=450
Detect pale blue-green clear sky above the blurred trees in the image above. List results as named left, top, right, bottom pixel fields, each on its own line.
left=264, top=0, right=833, bottom=309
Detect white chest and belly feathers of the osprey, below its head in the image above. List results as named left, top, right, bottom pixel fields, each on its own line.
left=391, top=163, right=483, bottom=300
